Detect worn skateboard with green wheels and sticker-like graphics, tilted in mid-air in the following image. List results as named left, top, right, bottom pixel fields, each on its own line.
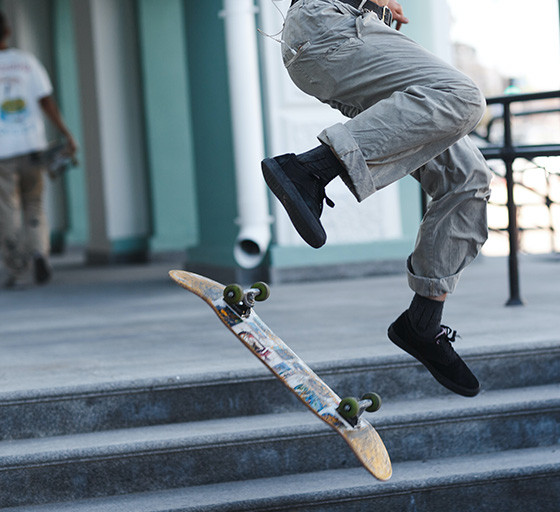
left=169, top=270, right=392, bottom=480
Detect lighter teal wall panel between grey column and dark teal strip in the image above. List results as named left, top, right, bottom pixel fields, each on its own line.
left=137, top=0, right=198, bottom=251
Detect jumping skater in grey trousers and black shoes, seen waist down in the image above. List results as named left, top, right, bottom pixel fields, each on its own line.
left=262, top=0, right=491, bottom=396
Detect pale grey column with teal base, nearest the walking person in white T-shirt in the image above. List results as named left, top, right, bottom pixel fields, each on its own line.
left=73, top=0, right=150, bottom=263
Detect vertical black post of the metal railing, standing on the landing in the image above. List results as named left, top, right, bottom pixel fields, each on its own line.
left=504, top=101, right=524, bottom=306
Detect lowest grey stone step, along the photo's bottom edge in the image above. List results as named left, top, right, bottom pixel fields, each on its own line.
left=8, top=446, right=560, bottom=512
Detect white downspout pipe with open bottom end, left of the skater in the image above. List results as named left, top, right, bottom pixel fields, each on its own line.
left=220, top=0, right=271, bottom=269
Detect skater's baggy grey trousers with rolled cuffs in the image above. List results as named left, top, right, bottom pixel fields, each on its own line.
left=282, top=0, right=491, bottom=297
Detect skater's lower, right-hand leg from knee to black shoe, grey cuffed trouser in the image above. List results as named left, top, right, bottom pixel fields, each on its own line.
left=389, top=138, right=491, bottom=396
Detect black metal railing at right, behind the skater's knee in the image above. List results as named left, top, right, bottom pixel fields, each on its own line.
left=476, top=91, right=560, bottom=306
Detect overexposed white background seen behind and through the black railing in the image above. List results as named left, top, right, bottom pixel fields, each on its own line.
left=448, top=0, right=560, bottom=255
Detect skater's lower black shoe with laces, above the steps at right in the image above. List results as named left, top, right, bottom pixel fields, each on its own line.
left=388, top=311, right=480, bottom=396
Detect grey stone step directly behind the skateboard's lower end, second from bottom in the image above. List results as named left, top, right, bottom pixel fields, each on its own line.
left=0, top=385, right=560, bottom=506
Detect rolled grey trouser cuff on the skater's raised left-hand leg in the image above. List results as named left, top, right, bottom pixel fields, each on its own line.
left=317, top=123, right=376, bottom=202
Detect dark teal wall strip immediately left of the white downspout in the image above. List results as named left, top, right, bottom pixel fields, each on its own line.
left=184, top=0, right=237, bottom=267
